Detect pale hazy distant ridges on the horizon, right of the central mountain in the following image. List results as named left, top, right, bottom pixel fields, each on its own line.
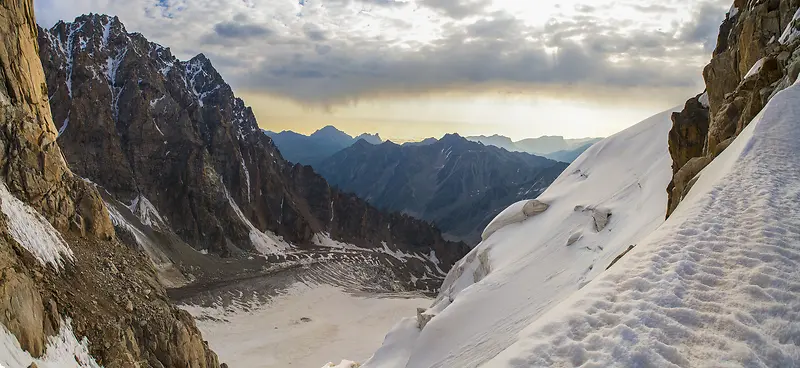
left=467, top=134, right=602, bottom=162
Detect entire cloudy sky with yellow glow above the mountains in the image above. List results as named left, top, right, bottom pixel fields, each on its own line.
left=34, top=0, right=732, bottom=140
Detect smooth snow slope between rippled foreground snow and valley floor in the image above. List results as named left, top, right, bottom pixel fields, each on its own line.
left=364, top=109, right=677, bottom=368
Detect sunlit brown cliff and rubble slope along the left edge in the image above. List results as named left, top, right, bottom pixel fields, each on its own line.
left=0, top=0, right=219, bottom=367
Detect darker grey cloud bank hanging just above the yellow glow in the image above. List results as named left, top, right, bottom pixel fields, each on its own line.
left=233, top=9, right=699, bottom=102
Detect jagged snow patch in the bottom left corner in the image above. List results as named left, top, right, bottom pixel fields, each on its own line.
left=0, top=320, right=100, bottom=368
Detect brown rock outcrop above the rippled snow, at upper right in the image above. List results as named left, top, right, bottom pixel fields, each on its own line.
left=667, top=0, right=800, bottom=216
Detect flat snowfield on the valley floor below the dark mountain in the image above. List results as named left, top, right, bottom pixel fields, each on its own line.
left=181, top=283, right=430, bottom=368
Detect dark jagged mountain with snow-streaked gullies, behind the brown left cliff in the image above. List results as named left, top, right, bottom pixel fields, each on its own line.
left=39, top=14, right=466, bottom=288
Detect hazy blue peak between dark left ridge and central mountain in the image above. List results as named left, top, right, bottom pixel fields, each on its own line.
left=265, top=125, right=383, bottom=166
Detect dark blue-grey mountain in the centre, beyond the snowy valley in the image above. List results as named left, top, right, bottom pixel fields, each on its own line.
left=319, top=135, right=566, bottom=242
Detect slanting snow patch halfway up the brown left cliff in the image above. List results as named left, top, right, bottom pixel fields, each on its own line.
left=0, top=182, right=72, bottom=270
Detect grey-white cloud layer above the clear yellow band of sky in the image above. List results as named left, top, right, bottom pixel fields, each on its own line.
left=35, top=0, right=726, bottom=102
